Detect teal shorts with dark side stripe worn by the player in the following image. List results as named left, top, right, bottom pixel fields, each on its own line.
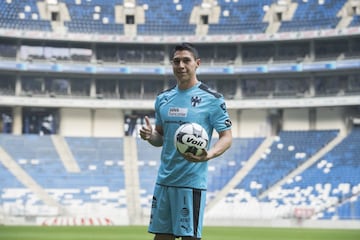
left=148, top=184, right=206, bottom=238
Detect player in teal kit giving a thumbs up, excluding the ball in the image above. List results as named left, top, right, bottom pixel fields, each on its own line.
left=140, top=43, right=232, bottom=240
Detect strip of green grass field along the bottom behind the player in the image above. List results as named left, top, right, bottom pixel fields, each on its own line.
left=0, top=226, right=360, bottom=240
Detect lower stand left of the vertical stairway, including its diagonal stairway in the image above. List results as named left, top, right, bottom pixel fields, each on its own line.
left=0, top=135, right=126, bottom=219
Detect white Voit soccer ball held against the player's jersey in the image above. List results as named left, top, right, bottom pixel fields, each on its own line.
left=174, top=123, right=209, bottom=156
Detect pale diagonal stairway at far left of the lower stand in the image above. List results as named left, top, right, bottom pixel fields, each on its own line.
left=0, top=146, right=66, bottom=214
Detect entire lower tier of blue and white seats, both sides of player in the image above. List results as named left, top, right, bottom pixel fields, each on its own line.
left=0, top=128, right=360, bottom=223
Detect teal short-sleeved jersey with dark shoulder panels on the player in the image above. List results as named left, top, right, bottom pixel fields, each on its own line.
left=155, top=82, right=231, bottom=189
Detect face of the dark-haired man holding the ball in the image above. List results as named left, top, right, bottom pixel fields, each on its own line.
left=171, top=50, right=200, bottom=82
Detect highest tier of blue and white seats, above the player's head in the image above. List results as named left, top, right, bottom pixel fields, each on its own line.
left=0, top=0, right=359, bottom=35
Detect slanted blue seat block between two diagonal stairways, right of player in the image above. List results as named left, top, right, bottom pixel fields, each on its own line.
left=237, top=130, right=338, bottom=197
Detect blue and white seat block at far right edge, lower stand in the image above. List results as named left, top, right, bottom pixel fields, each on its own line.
left=276, top=127, right=360, bottom=219
